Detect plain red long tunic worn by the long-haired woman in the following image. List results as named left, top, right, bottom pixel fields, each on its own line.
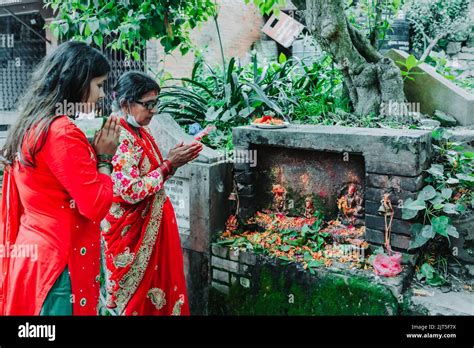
left=1, top=116, right=113, bottom=315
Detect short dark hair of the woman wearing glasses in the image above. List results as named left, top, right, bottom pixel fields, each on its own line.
left=112, top=70, right=160, bottom=111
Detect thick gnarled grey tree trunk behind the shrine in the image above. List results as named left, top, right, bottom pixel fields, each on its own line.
left=292, top=0, right=405, bottom=116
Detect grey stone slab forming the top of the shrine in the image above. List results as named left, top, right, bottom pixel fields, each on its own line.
left=233, top=125, right=432, bottom=176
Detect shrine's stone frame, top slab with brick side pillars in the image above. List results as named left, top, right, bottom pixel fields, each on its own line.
left=233, top=125, right=432, bottom=250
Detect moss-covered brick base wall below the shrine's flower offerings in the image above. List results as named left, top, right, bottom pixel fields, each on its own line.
left=209, top=243, right=415, bottom=315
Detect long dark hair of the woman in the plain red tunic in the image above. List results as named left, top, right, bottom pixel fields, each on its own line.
left=2, top=41, right=110, bottom=166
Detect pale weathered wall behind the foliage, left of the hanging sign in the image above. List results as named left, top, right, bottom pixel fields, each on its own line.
left=147, top=0, right=264, bottom=77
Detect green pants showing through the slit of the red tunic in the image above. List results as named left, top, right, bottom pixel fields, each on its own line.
left=39, top=266, right=72, bottom=315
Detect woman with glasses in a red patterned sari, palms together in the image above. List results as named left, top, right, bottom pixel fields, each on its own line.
left=101, top=72, right=202, bottom=315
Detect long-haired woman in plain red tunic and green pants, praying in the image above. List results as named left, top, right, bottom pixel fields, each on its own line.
left=0, top=42, right=120, bottom=315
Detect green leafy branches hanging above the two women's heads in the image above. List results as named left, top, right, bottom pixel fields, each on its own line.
left=45, top=0, right=216, bottom=56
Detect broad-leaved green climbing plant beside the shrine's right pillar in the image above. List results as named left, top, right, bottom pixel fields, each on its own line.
left=402, top=128, right=474, bottom=249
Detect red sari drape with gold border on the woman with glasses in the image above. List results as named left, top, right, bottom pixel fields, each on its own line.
left=102, top=120, right=189, bottom=315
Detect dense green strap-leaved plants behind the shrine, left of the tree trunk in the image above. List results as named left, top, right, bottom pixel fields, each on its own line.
left=159, top=53, right=342, bottom=148
